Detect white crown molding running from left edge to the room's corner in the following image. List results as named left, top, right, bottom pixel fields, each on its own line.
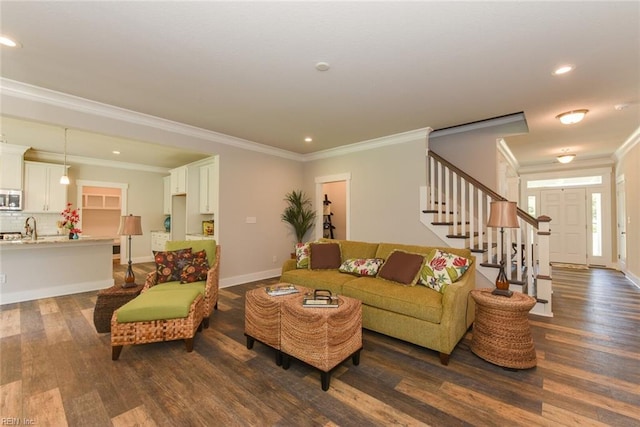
left=0, top=78, right=302, bottom=161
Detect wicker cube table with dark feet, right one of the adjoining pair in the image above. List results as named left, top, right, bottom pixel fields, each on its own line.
left=280, top=295, right=362, bottom=391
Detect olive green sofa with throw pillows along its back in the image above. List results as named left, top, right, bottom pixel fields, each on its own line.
left=280, top=239, right=476, bottom=365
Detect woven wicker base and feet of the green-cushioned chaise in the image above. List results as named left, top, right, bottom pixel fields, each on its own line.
left=111, top=294, right=204, bottom=360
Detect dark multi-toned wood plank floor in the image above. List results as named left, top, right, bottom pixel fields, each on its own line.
left=0, top=265, right=640, bottom=426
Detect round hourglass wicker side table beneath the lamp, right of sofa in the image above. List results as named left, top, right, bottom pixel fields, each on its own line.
left=471, top=288, right=537, bottom=369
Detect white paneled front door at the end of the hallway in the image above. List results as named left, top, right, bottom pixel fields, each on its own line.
left=540, top=188, right=587, bottom=264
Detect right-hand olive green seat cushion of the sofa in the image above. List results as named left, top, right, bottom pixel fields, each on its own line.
left=342, top=277, right=442, bottom=324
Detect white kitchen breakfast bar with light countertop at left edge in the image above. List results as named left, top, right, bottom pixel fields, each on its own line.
left=0, top=236, right=113, bottom=305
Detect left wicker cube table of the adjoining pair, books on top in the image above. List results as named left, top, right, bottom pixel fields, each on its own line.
left=244, top=285, right=313, bottom=366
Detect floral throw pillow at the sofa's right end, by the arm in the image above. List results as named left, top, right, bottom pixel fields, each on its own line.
left=418, top=249, right=471, bottom=293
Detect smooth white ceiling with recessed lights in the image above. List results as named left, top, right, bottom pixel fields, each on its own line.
left=0, top=0, right=640, bottom=169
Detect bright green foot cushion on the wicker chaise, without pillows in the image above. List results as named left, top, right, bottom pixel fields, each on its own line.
left=117, top=287, right=199, bottom=323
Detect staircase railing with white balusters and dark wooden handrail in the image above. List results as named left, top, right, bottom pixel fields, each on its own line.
left=420, top=151, right=553, bottom=317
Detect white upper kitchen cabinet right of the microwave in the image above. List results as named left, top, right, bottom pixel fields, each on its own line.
left=24, top=162, right=67, bottom=213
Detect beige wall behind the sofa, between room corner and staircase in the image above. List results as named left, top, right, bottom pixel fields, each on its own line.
left=304, top=132, right=442, bottom=245
